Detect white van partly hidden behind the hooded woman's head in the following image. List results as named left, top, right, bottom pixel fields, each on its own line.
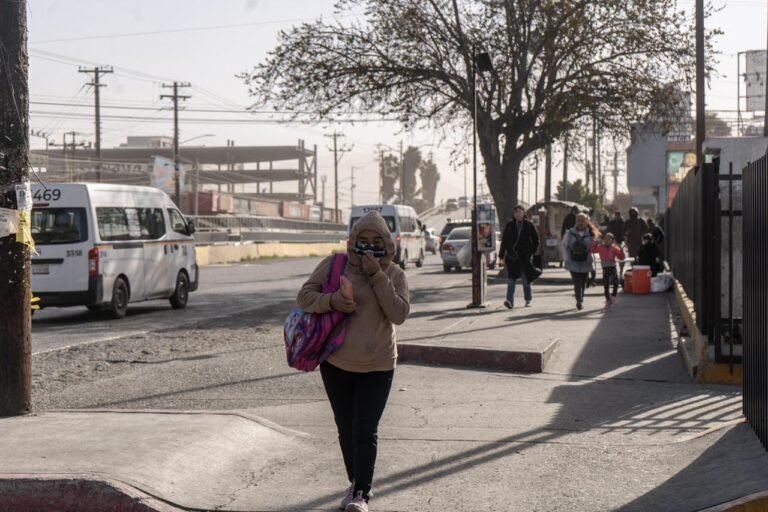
left=349, top=204, right=425, bottom=269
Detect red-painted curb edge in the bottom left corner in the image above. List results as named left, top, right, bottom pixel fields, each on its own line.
left=0, top=474, right=183, bottom=512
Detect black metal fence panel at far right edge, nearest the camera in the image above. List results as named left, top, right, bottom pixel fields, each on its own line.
left=743, top=152, right=768, bottom=448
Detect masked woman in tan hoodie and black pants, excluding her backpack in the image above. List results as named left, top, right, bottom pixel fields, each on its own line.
left=298, top=211, right=410, bottom=512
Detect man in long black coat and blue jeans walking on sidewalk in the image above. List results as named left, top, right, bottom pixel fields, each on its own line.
left=499, top=205, right=541, bottom=309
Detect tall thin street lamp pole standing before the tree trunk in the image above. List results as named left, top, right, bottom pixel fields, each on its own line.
left=467, top=47, right=493, bottom=308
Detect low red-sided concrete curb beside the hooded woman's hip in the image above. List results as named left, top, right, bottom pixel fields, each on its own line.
left=397, top=339, right=560, bottom=373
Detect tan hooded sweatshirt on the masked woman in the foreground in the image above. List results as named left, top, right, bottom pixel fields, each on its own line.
left=297, top=212, right=410, bottom=372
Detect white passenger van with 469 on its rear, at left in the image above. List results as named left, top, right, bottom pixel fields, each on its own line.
left=31, top=183, right=199, bottom=318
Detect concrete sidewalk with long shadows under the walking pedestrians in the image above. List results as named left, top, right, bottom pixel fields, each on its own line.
left=0, top=269, right=768, bottom=512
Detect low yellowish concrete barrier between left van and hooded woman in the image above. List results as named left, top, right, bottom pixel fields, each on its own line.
left=195, top=242, right=346, bottom=267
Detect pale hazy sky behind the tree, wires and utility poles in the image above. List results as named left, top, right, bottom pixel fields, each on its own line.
left=28, top=0, right=768, bottom=206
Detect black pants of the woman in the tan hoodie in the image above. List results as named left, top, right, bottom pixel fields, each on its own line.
left=320, top=362, right=395, bottom=498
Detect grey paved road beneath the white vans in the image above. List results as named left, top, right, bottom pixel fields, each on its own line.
left=32, top=251, right=469, bottom=353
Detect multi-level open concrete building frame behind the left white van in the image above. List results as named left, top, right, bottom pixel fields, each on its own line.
left=31, top=137, right=340, bottom=220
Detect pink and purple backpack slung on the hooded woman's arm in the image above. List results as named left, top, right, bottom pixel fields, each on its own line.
left=283, top=253, right=349, bottom=372
